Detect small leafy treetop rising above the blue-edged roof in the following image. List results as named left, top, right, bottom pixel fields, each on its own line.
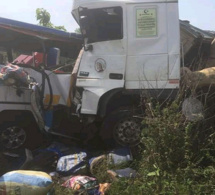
left=36, top=8, right=66, bottom=31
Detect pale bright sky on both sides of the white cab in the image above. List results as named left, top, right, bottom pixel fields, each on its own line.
left=0, top=0, right=215, bottom=32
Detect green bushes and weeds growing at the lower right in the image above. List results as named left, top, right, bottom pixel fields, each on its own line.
left=109, top=100, right=215, bottom=195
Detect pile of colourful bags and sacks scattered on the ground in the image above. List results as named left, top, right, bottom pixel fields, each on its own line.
left=0, top=143, right=137, bottom=195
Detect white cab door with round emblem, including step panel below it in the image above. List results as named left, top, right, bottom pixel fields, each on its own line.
left=76, top=6, right=127, bottom=114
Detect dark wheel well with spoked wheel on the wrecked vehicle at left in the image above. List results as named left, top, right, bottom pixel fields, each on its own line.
left=0, top=110, right=48, bottom=151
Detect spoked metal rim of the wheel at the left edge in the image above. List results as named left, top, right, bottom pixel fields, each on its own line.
left=0, top=126, right=26, bottom=149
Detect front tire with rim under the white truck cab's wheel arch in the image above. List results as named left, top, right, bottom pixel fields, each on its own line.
left=100, top=108, right=142, bottom=147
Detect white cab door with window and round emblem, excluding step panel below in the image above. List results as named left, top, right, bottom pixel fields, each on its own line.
left=78, top=6, right=127, bottom=82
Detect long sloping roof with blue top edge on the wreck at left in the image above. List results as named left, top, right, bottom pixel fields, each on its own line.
left=0, top=17, right=82, bottom=57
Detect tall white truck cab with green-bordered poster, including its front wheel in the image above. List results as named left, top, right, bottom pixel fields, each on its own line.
left=72, top=0, right=180, bottom=143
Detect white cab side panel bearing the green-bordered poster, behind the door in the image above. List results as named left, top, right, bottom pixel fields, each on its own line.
left=125, top=3, right=168, bottom=89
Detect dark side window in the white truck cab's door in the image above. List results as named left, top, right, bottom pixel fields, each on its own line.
left=80, top=7, right=123, bottom=43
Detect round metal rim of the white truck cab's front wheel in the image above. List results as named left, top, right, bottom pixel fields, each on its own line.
left=113, top=118, right=141, bottom=146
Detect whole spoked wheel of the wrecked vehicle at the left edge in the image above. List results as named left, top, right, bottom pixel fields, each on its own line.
left=0, top=123, right=27, bottom=150
